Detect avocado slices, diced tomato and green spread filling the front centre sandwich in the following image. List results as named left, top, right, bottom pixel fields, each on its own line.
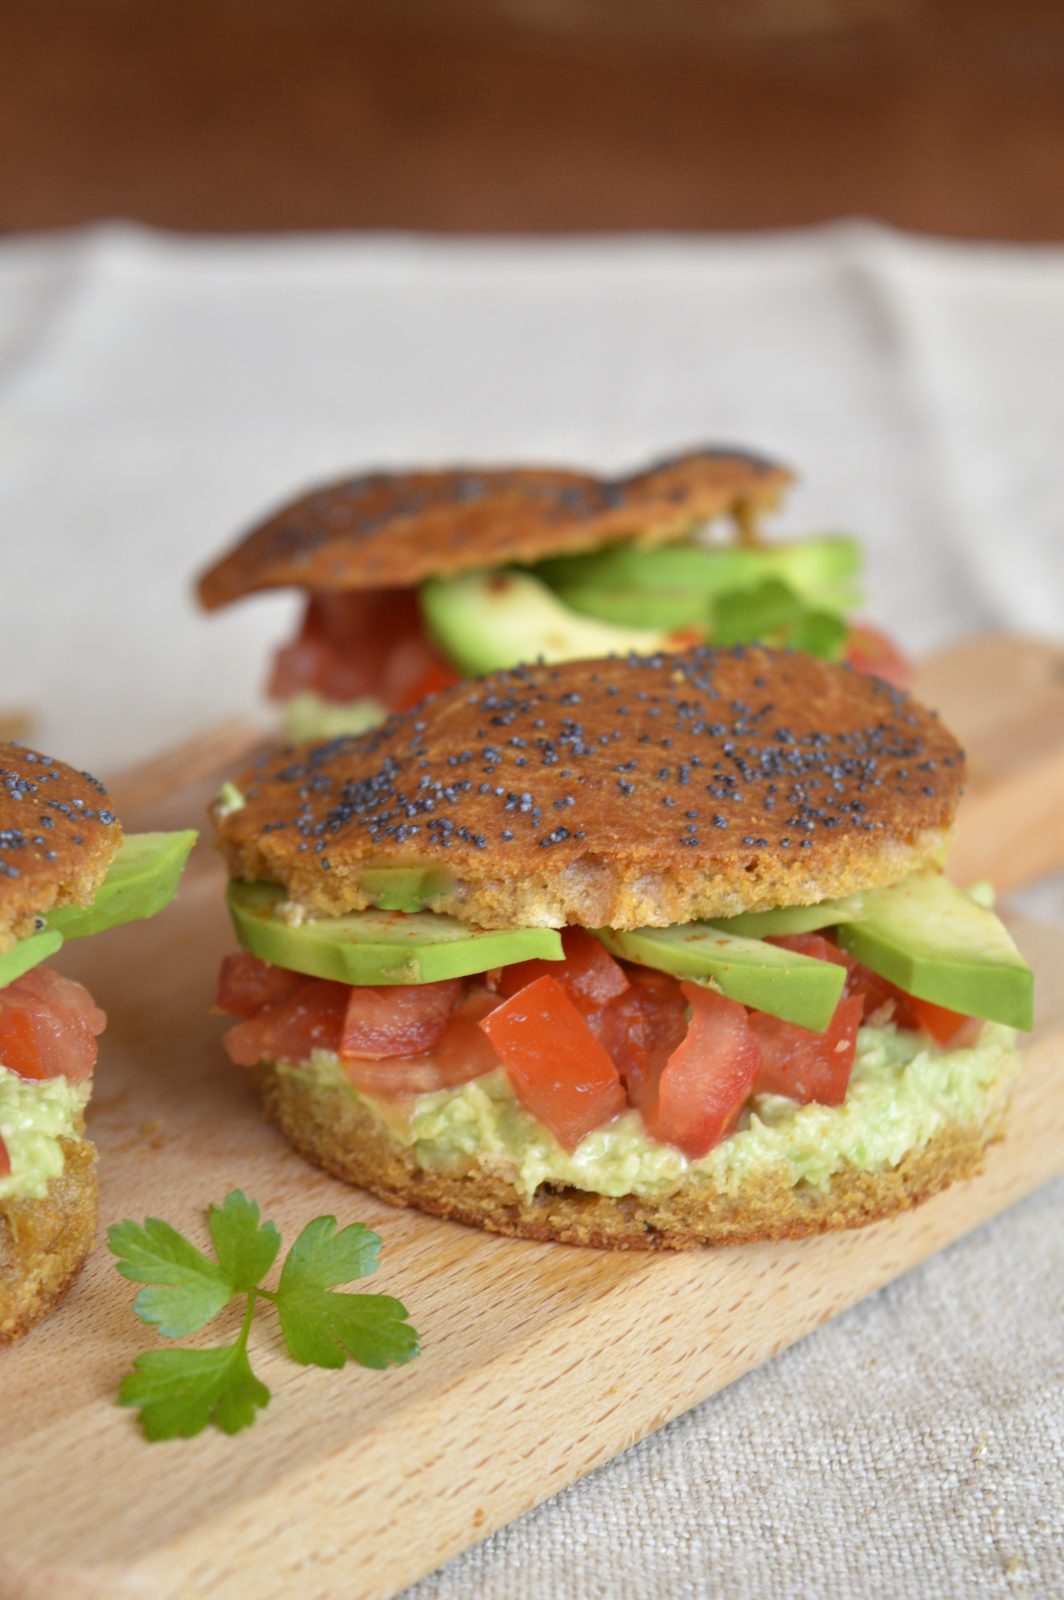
left=216, top=870, right=1030, bottom=1197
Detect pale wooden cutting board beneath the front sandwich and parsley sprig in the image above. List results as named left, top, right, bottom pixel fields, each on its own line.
left=0, top=627, right=1064, bottom=1600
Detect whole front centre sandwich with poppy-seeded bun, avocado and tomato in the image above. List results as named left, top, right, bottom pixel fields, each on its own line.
left=214, top=646, right=1032, bottom=1250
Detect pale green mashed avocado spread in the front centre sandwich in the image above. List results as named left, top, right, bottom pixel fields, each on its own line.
left=283, top=1022, right=1019, bottom=1197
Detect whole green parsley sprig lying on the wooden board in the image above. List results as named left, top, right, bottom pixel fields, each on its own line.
left=107, top=1189, right=418, bottom=1440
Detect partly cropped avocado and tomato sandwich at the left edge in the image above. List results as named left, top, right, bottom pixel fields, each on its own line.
left=0, top=742, right=197, bottom=1344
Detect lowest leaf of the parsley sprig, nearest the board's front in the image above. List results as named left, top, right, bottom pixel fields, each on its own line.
left=118, top=1342, right=270, bottom=1440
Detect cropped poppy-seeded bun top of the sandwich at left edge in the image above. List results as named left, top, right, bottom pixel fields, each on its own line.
left=0, top=741, right=122, bottom=950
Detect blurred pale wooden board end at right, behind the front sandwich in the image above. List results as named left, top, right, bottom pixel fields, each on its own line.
left=915, top=634, right=1064, bottom=894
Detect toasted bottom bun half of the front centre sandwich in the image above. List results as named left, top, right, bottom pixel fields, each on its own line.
left=258, top=1064, right=1005, bottom=1250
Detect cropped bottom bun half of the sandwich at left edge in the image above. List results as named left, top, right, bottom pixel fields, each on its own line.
left=0, top=1139, right=96, bottom=1344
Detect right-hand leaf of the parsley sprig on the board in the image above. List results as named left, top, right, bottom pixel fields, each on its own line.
left=272, top=1216, right=418, bottom=1368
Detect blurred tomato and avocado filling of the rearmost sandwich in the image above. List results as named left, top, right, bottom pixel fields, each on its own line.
left=269, top=536, right=910, bottom=739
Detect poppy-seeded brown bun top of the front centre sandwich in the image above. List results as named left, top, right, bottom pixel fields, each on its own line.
left=218, top=648, right=965, bottom=928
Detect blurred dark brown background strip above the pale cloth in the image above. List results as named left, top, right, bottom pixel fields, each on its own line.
left=0, top=0, right=1064, bottom=238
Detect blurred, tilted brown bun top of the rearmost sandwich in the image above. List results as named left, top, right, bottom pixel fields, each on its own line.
left=198, top=448, right=790, bottom=611
